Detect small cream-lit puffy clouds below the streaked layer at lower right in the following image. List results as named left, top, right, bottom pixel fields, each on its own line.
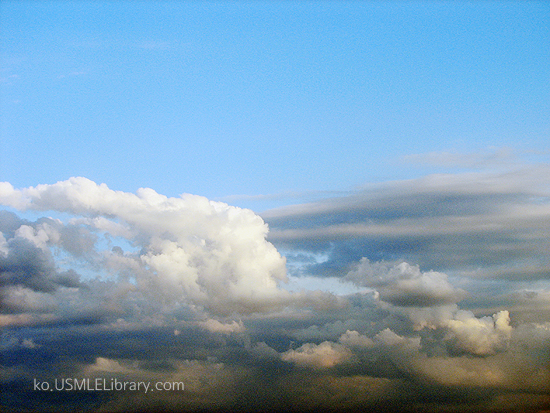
left=346, top=258, right=512, bottom=356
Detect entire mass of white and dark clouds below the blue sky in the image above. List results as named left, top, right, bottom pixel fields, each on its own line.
left=0, top=166, right=550, bottom=412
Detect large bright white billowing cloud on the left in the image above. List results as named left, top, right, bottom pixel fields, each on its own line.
left=0, top=178, right=287, bottom=314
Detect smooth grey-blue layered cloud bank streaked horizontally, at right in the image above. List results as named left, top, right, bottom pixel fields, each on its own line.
left=262, top=164, right=550, bottom=279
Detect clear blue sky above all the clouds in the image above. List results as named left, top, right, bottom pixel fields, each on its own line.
left=0, top=1, right=550, bottom=209
